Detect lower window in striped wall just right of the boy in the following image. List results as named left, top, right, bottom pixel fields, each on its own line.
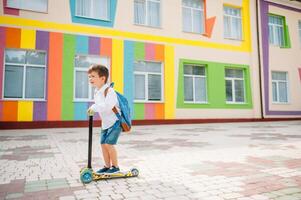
left=134, top=61, right=163, bottom=102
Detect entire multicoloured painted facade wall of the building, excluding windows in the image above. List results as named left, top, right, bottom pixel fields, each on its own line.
left=0, top=0, right=301, bottom=126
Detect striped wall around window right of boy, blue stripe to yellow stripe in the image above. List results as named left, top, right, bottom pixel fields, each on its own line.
left=123, top=41, right=174, bottom=119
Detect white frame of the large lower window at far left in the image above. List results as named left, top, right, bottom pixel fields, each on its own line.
left=2, top=48, right=48, bottom=102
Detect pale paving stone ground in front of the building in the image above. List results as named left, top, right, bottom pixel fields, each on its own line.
left=0, top=121, right=301, bottom=200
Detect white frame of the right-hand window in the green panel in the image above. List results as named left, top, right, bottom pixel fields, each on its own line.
left=224, top=67, right=247, bottom=104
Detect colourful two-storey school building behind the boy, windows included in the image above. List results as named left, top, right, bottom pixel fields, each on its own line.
left=0, top=0, right=301, bottom=128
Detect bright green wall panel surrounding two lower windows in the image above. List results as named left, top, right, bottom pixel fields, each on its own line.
left=177, top=59, right=253, bottom=109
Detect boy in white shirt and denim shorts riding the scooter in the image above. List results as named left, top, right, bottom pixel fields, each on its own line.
left=87, top=65, right=121, bottom=174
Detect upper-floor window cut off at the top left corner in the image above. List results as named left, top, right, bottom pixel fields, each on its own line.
left=6, top=0, right=48, bottom=12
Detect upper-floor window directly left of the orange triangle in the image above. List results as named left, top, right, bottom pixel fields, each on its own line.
left=182, top=0, right=205, bottom=33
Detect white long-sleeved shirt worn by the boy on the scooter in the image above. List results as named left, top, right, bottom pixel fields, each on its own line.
left=90, top=84, right=120, bottom=130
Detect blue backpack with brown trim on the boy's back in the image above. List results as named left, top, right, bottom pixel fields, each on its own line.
left=105, top=83, right=132, bottom=132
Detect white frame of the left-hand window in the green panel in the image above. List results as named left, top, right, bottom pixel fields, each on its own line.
left=183, top=63, right=208, bottom=104
